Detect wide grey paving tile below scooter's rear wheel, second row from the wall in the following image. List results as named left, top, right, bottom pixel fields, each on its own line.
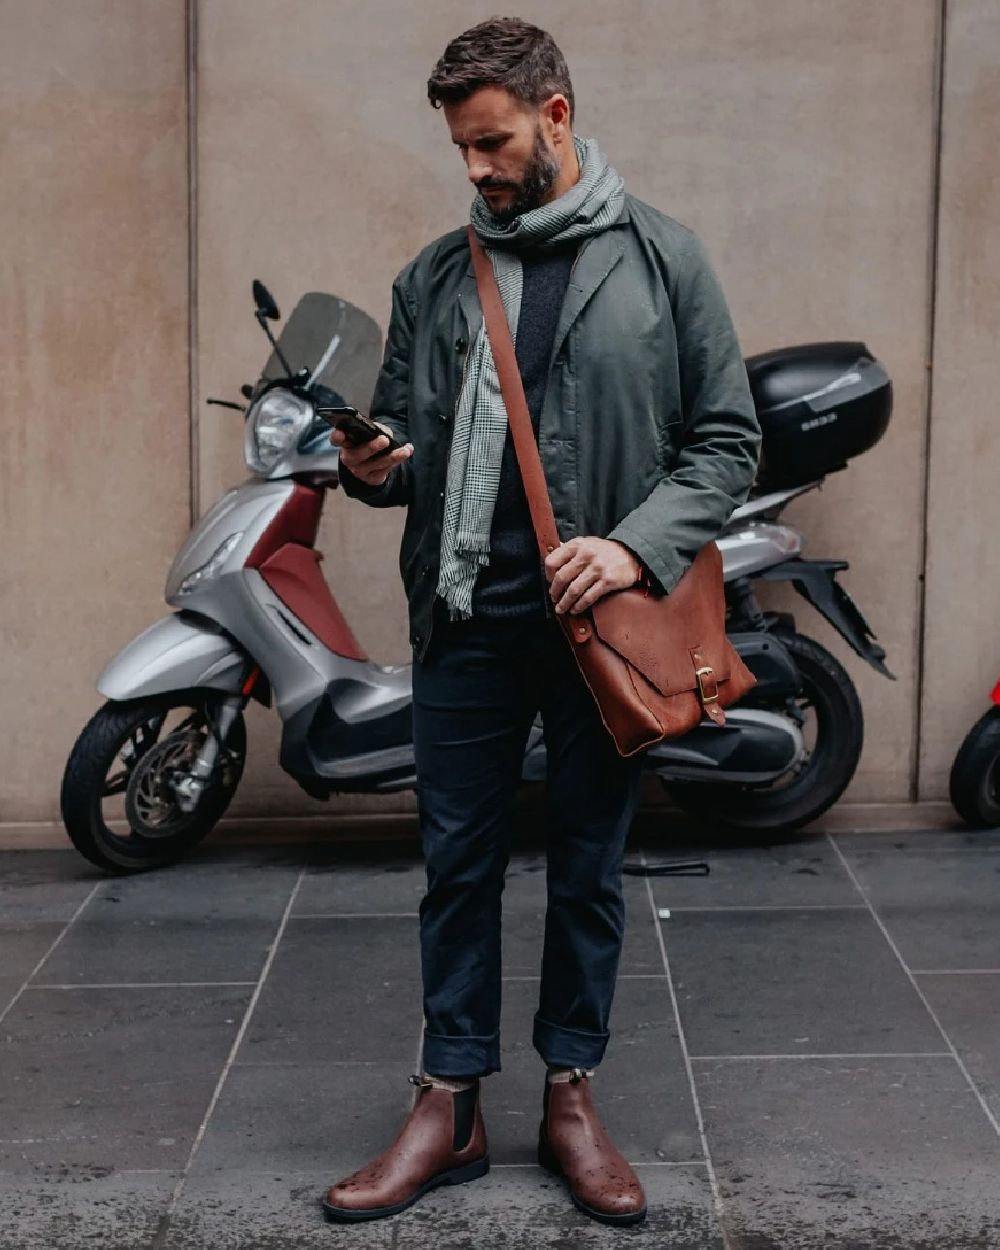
left=663, top=910, right=946, bottom=1055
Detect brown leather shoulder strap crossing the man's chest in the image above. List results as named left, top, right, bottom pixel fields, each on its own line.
left=469, top=226, right=560, bottom=555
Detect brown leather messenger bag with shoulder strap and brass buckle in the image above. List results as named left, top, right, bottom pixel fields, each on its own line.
left=469, top=226, right=756, bottom=755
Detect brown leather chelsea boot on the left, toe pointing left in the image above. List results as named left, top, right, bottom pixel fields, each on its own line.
left=323, top=1076, right=490, bottom=1221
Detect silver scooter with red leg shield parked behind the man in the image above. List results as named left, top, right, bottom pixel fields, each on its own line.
left=61, top=281, right=885, bottom=873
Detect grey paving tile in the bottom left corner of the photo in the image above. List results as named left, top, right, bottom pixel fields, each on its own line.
left=0, top=1168, right=178, bottom=1250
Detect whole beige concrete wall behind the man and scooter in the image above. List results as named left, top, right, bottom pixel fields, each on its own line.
left=0, top=0, right=1000, bottom=819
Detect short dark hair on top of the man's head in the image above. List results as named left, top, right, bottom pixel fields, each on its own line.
left=428, top=18, right=574, bottom=121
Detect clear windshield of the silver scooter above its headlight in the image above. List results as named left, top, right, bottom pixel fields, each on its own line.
left=261, top=291, right=383, bottom=413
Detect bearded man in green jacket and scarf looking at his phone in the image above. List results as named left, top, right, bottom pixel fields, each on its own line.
left=324, top=19, right=759, bottom=1224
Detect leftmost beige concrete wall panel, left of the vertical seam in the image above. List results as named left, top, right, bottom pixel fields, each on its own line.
left=0, top=0, right=190, bottom=820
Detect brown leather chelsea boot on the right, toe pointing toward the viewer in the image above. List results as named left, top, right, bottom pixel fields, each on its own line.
left=539, top=1068, right=646, bottom=1225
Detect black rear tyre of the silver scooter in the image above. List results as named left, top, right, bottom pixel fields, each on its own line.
left=664, top=631, right=865, bottom=834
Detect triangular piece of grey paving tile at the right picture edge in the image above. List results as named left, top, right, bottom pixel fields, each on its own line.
left=916, top=973, right=1000, bottom=1120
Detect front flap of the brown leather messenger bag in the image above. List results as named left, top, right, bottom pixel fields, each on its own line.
left=591, top=543, right=729, bottom=696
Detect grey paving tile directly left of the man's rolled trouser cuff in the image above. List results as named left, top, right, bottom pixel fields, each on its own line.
left=238, top=916, right=423, bottom=1071
